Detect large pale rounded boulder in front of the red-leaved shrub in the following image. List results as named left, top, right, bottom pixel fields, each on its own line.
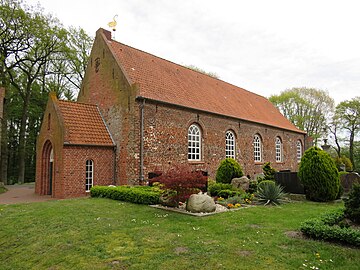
left=186, top=193, right=216, bottom=213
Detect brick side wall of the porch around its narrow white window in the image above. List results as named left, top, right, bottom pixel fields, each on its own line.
left=62, top=146, right=114, bottom=197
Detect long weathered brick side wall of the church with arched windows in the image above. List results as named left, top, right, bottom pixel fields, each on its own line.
left=139, top=102, right=304, bottom=181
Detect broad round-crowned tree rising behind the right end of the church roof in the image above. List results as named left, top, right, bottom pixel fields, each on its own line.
left=269, top=87, right=334, bottom=142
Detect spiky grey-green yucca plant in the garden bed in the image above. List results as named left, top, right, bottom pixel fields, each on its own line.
left=256, top=181, right=286, bottom=205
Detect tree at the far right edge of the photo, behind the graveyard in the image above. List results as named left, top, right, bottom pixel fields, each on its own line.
left=335, top=97, right=360, bottom=169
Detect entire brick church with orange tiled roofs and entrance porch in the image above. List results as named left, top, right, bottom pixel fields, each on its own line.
left=36, top=29, right=306, bottom=198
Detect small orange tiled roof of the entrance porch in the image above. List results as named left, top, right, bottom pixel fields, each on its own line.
left=57, top=100, right=114, bottom=146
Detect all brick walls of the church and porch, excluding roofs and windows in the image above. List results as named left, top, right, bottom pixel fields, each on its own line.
left=36, top=30, right=307, bottom=198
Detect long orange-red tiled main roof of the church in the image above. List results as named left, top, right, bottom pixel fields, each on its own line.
left=105, top=35, right=305, bottom=133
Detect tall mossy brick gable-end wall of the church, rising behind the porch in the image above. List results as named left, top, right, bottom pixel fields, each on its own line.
left=78, top=30, right=137, bottom=184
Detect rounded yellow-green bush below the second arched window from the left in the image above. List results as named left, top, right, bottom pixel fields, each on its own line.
left=216, top=158, right=244, bottom=184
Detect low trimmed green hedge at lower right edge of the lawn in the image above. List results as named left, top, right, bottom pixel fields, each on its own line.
left=300, top=209, right=360, bottom=247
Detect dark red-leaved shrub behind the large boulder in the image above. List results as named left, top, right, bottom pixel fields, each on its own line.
left=152, top=165, right=208, bottom=205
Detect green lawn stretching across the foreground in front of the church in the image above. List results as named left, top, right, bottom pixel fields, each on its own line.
left=0, top=198, right=360, bottom=270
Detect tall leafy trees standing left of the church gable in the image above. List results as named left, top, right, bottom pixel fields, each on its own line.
left=0, top=0, right=92, bottom=183
